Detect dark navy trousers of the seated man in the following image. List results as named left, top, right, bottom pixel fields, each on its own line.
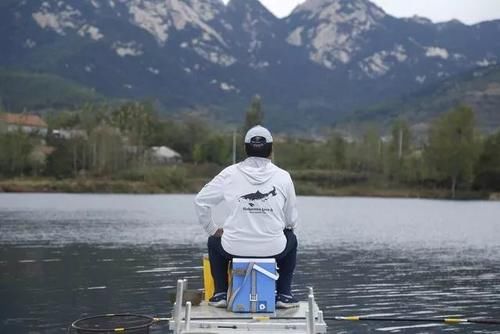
left=208, top=230, right=297, bottom=295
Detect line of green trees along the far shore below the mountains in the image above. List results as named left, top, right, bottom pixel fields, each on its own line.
left=0, top=97, right=500, bottom=197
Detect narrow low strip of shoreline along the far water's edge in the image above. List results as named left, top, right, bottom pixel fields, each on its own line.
left=0, top=178, right=500, bottom=201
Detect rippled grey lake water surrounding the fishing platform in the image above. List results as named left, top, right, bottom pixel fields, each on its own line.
left=0, top=194, right=500, bottom=334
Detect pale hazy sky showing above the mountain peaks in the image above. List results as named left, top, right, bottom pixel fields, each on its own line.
left=223, top=0, right=500, bottom=24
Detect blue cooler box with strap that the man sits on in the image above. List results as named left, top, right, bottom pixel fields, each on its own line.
left=228, top=258, right=279, bottom=313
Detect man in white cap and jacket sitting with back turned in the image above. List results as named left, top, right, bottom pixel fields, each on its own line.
left=195, top=126, right=298, bottom=308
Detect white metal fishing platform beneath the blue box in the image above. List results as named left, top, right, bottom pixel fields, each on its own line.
left=169, top=280, right=327, bottom=334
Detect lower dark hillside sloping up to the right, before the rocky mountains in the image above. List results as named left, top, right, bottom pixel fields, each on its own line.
left=350, top=65, right=500, bottom=134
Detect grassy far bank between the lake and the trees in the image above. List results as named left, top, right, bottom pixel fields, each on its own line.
left=0, top=164, right=492, bottom=200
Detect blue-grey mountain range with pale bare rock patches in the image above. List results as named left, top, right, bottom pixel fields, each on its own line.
left=0, top=0, right=500, bottom=129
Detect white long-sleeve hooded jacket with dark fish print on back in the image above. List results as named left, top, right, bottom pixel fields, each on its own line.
left=195, top=157, right=298, bottom=256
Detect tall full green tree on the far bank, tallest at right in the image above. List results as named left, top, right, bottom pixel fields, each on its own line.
left=425, top=106, right=476, bottom=198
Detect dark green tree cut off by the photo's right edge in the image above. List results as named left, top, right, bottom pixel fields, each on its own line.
left=474, top=131, right=500, bottom=191
